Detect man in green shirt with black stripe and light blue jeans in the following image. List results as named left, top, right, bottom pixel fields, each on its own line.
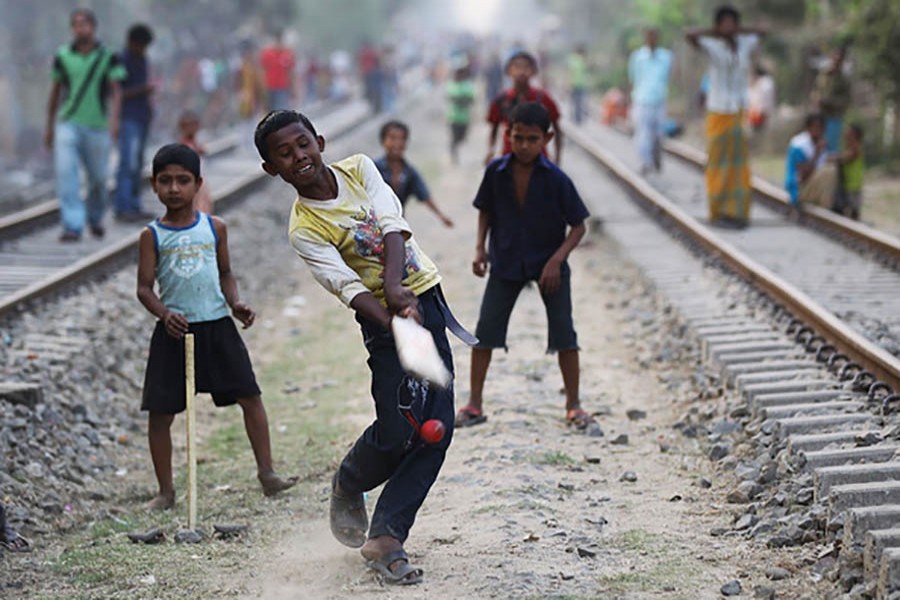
left=44, top=8, right=126, bottom=242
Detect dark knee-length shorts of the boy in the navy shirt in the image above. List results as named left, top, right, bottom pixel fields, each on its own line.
left=475, top=267, right=578, bottom=352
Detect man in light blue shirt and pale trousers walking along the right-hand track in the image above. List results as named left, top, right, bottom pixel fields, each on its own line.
left=628, top=28, right=672, bottom=174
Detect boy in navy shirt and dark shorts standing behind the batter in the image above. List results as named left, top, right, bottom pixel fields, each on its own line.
left=456, top=102, right=593, bottom=429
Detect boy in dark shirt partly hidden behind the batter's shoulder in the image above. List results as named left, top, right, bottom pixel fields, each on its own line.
left=375, top=121, right=453, bottom=227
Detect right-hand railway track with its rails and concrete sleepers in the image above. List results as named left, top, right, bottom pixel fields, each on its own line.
left=566, top=119, right=900, bottom=598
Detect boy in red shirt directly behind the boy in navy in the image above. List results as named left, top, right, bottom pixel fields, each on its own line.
left=484, top=50, right=563, bottom=165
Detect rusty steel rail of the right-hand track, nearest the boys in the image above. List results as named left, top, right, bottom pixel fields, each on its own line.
left=566, top=126, right=900, bottom=390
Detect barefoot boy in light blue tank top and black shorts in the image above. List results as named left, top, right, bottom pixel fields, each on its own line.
left=137, top=144, right=297, bottom=510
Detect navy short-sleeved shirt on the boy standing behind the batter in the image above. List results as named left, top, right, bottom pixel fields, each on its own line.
left=473, top=154, right=588, bottom=281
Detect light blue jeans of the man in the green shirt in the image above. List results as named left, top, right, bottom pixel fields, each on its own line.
left=53, top=121, right=110, bottom=234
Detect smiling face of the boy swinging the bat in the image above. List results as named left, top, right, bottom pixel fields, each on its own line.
left=263, top=123, right=325, bottom=191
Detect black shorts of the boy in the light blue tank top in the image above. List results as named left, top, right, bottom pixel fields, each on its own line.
left=141, top=317, right=260, bottom=415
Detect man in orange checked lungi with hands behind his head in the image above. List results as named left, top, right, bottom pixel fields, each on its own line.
left=685, top=6, right=765, bottom=228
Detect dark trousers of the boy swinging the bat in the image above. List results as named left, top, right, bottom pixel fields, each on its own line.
left=338, top=289, right=454, bottom=543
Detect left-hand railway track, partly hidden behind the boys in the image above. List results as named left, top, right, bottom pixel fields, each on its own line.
left=0, top=100, right=370, bottom=316
